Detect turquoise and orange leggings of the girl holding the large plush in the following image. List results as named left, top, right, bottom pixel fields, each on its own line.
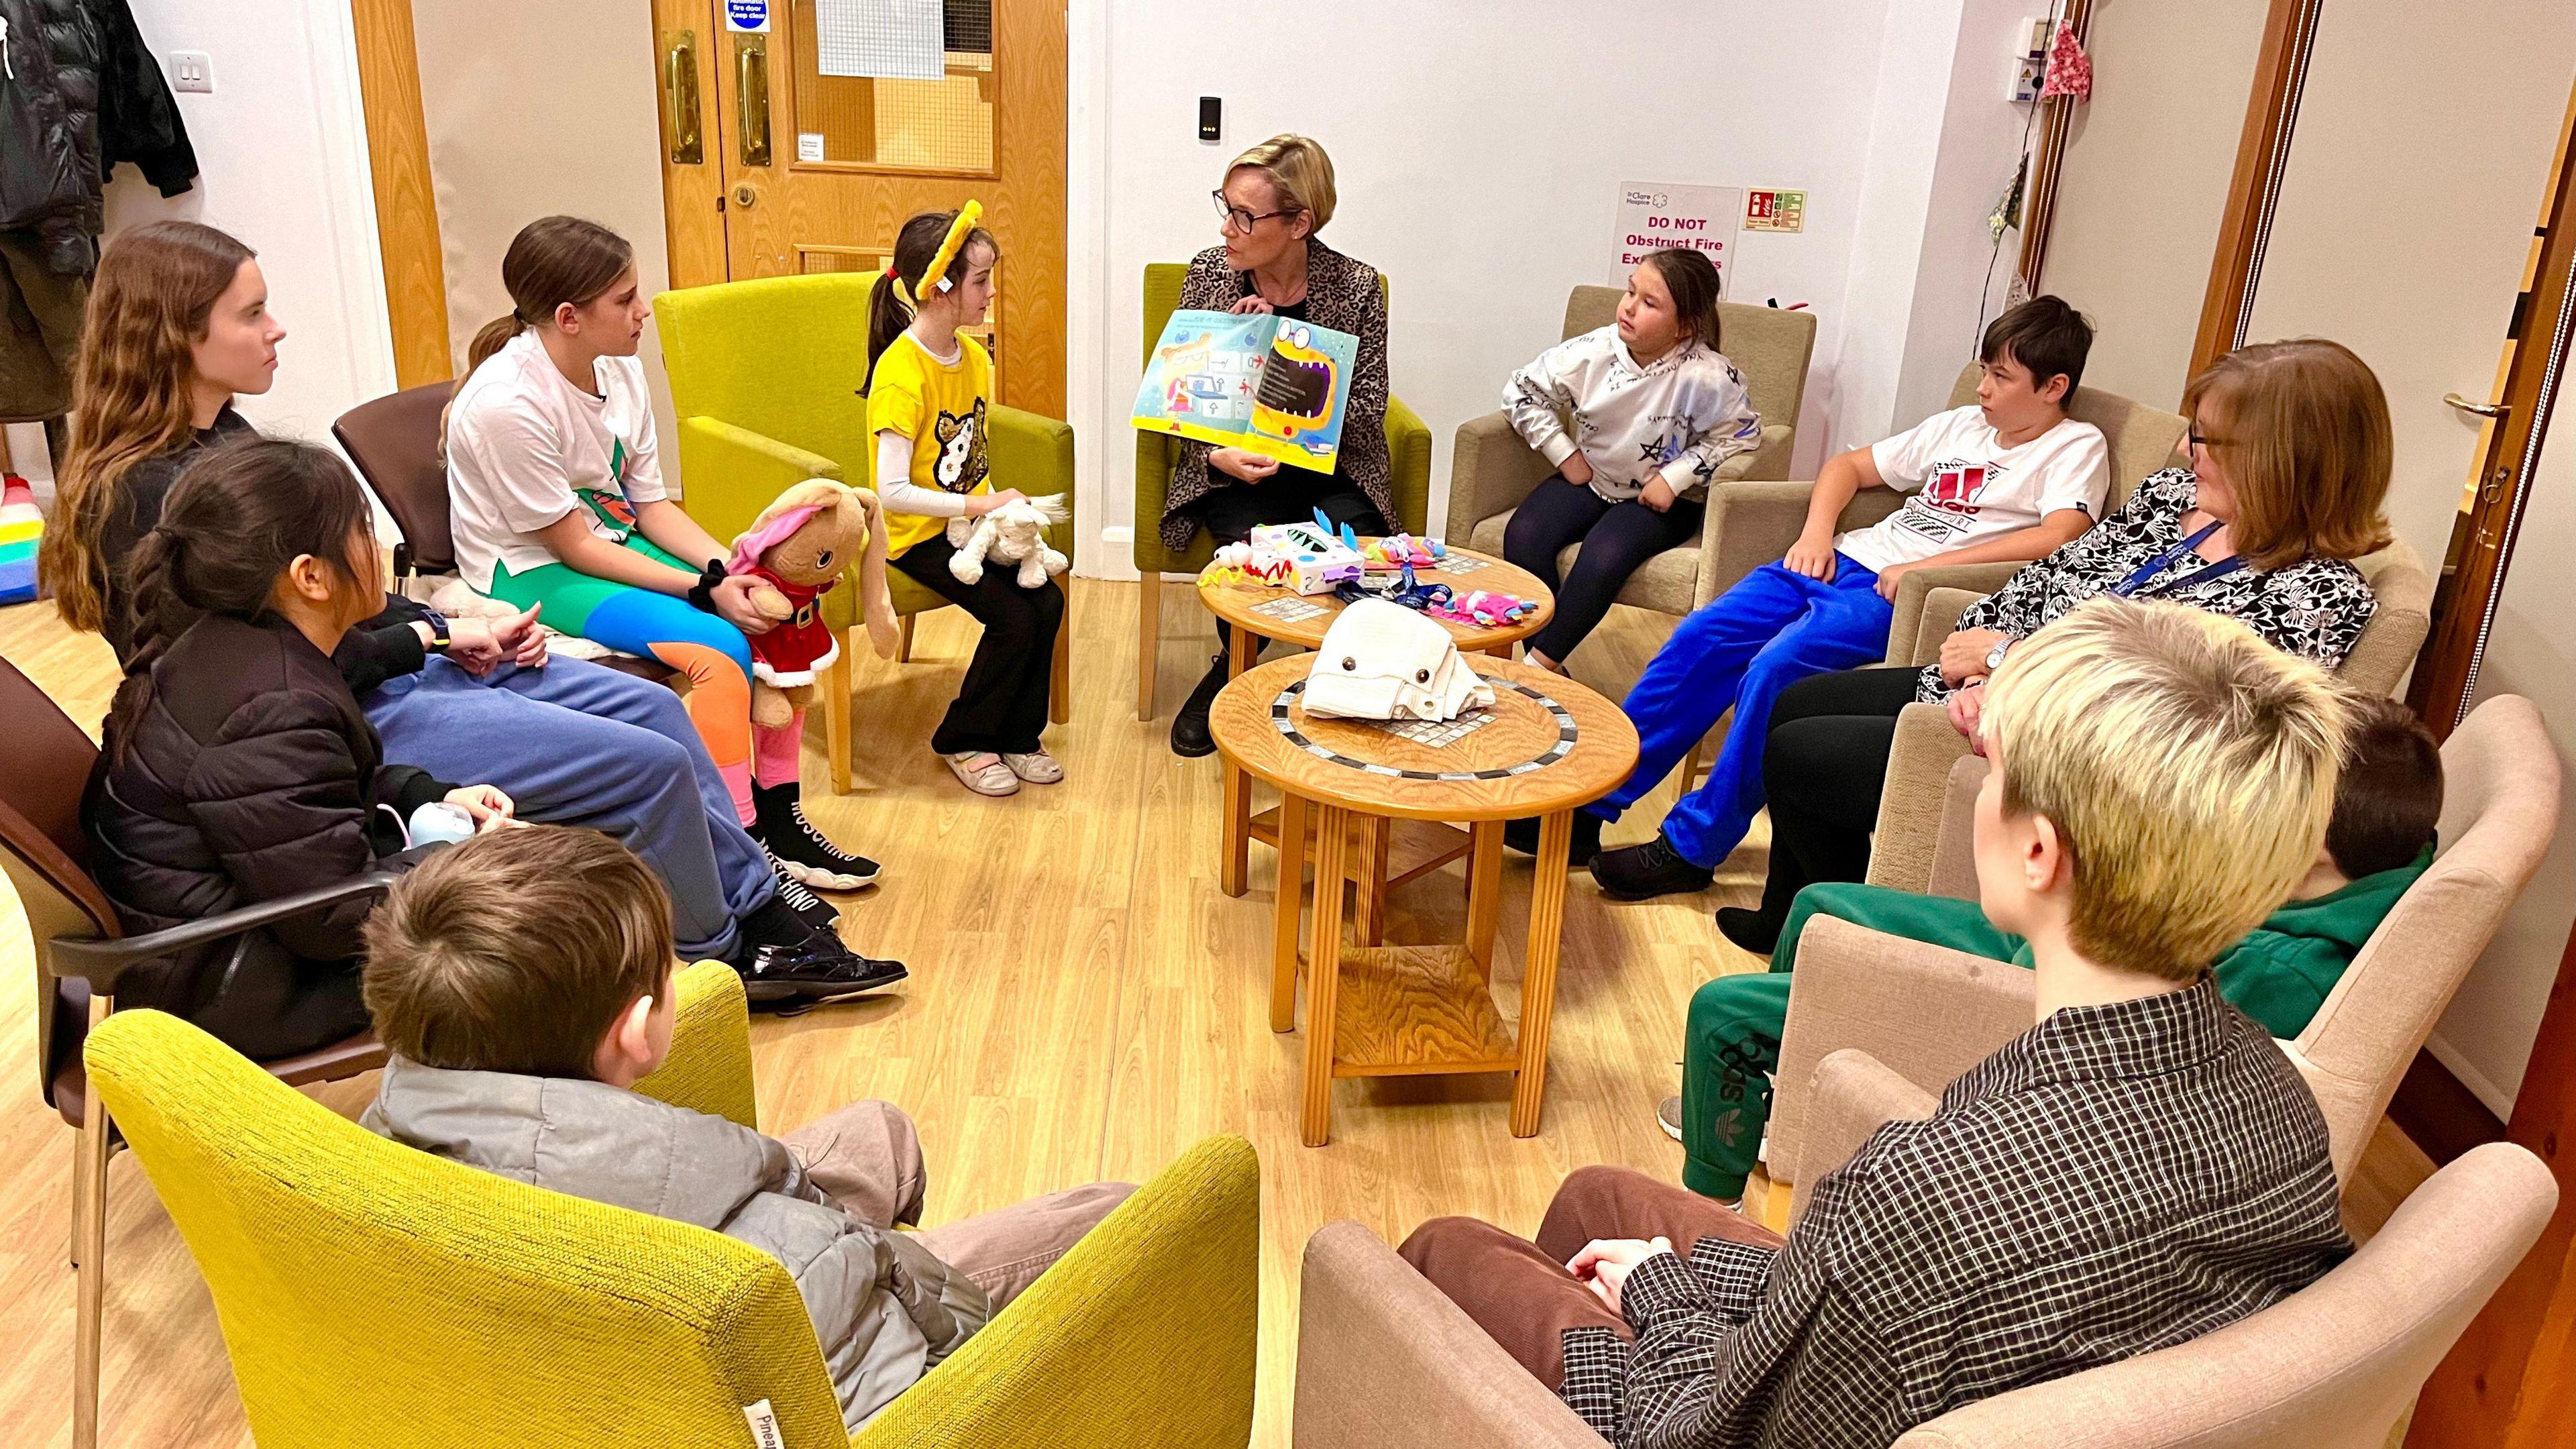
left=492, top=534, right=804, bottom=825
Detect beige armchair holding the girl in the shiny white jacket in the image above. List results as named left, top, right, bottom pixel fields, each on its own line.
left=1442, top=286, right=1823, bottom=626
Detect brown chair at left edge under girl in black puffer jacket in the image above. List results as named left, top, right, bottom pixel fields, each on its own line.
left=0, top=660, right=394, bottom=1449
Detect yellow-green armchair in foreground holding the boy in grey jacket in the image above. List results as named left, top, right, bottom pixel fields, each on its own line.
left=85, top=962, right=1260, bottom=1449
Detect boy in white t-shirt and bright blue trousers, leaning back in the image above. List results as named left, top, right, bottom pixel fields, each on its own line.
left=1520, top=297, right=2110, bottom=900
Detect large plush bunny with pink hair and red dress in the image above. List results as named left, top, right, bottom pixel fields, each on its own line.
left=724, top=477, right=894, bottom=730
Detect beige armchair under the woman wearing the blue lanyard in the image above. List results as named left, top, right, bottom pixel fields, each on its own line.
left=1870, top=539, right=2432, bottom=895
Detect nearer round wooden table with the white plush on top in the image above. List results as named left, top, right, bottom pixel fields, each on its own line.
left=1208, top=655, right=1635, bottom=1147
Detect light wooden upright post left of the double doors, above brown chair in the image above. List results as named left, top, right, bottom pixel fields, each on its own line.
left=347, top=0, right=456, bottom=387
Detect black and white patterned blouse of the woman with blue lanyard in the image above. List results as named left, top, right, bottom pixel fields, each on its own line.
left=1914, top=467, right=2380, bottom=704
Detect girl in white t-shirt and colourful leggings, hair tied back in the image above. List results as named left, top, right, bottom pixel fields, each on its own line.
left=448, top=217, right=876, bottom=890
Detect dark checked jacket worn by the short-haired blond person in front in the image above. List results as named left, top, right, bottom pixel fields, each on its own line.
left=1561, top=975, right=2352, bottom=1449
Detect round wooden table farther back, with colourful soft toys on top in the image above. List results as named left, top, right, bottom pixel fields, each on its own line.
left=1198, top=539, right=1556, bottom=902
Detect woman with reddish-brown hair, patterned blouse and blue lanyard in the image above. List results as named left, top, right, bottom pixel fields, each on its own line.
left=1718, top=337, right=2391, bottom=954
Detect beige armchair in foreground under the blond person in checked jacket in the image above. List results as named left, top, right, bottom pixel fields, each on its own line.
left=1293, top=1046, right=2558, bottom=1449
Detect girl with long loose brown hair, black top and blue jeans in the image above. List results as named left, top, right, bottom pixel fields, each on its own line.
left=41, top=222, right=899, bottom=990
